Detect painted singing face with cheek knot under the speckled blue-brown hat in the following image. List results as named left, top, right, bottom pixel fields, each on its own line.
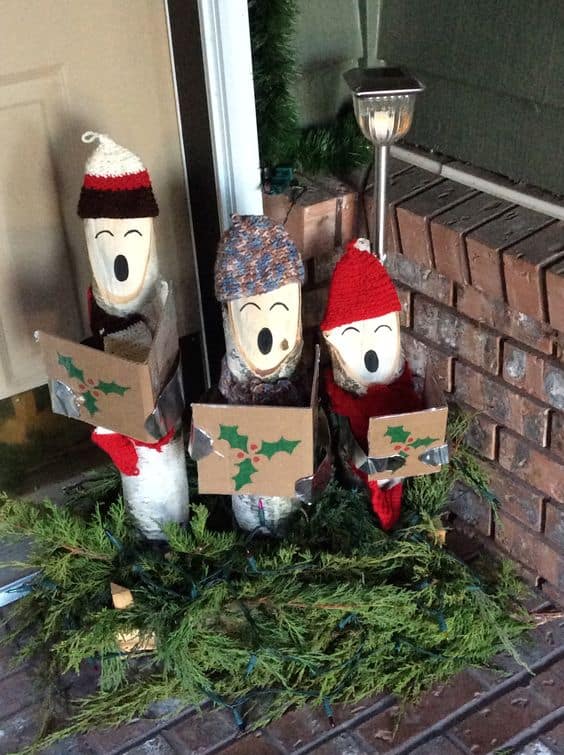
left=228, top=283, right=301, bottom=377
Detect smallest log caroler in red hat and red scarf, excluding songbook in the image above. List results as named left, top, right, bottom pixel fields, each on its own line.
left=321, top=239, right=421, bottom=530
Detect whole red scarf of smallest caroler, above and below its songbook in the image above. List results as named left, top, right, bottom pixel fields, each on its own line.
left=325, top=362, right=421, bottom=530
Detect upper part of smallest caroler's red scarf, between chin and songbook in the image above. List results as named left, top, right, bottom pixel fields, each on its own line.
left=325, top=362, right=421, bottom=452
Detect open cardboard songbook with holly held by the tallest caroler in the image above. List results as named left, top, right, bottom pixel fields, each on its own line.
left=35, top=293, right=178, bottom=443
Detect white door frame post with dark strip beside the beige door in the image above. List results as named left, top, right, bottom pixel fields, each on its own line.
left=164, top=0, right=263, bottom=387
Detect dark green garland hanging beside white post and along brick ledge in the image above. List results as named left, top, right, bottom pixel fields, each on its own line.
left=249, top=0, right=373, bottom=174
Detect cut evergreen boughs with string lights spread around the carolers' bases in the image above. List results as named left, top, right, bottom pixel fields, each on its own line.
left=0, top=417, right=527, bottom=746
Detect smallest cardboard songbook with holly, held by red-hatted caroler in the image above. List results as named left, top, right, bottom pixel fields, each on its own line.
left=368, top=372, right=448, bottom=480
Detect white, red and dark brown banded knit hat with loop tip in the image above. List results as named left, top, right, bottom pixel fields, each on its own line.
left=78, top=131, right=159, bottom=218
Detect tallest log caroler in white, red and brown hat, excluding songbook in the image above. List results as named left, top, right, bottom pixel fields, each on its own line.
left=78, top=131, right=189, bottom=539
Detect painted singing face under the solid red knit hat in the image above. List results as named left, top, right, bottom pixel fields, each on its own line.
left=323, top=312, right=401, bottom=386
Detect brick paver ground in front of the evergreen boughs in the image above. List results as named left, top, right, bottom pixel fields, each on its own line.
left=0, top=600, right=564, bottom=755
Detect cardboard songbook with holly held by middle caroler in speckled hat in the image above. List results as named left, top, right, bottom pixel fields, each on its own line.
left=191, top=350, right=319, bottom=496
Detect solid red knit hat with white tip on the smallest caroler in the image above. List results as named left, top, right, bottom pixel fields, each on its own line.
left=321, top=239, right=401, bottom=330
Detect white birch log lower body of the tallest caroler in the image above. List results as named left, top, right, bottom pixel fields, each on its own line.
left=121, top=434, right=189, bottom=540
